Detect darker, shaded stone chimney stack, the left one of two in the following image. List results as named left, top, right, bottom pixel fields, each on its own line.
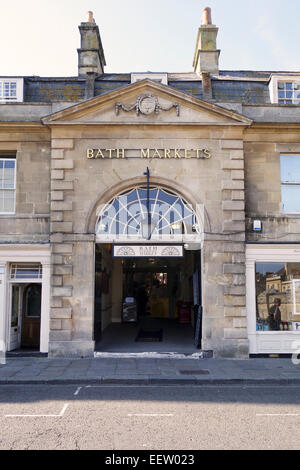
left=77, top=11, right=106, bottom=77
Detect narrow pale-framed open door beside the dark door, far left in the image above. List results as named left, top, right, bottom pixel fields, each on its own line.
left=8, top=284, right=22, bottom=351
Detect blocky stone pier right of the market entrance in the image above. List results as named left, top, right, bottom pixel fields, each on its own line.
left=203, top=140, right=249, bottom=357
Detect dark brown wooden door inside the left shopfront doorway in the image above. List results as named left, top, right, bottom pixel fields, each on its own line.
left=21, top=284, right=42, bottom=348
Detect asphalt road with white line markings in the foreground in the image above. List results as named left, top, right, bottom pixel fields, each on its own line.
left=0, top=385, right=300, bottom=450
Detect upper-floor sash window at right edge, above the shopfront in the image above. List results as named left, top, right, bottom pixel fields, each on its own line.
left=280, top=154, right=300, bottom=212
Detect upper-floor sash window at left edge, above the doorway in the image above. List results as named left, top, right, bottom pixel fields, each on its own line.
left=0, top=157, right=16, bottom=214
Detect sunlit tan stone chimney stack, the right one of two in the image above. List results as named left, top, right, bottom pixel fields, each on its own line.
left=193, top=7, right=220, bottom=75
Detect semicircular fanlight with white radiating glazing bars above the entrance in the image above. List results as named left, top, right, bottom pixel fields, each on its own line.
left=96, top=187, right=199, bottom=240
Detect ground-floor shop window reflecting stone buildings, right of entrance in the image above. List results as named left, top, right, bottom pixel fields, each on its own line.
left=255, top=263, right=300, bottom=332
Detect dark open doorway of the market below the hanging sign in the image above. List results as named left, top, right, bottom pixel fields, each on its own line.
left=94, top=244, right=201, bottom=353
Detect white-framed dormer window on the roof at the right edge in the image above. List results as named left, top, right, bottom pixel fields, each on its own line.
left=269, top=75, right=300, bottom=105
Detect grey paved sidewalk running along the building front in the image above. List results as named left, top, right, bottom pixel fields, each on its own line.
left=0, top=357, right=300, bottom=385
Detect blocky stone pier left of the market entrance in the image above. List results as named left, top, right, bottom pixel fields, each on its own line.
left=49, top=139, right=94, bottom=356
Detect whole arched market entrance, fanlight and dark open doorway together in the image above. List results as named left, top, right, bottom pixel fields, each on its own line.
left=94, top=184, right=203, bottom=352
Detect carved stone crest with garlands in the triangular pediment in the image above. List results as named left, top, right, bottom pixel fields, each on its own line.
left=115, top=93, right=179, bottom=116
